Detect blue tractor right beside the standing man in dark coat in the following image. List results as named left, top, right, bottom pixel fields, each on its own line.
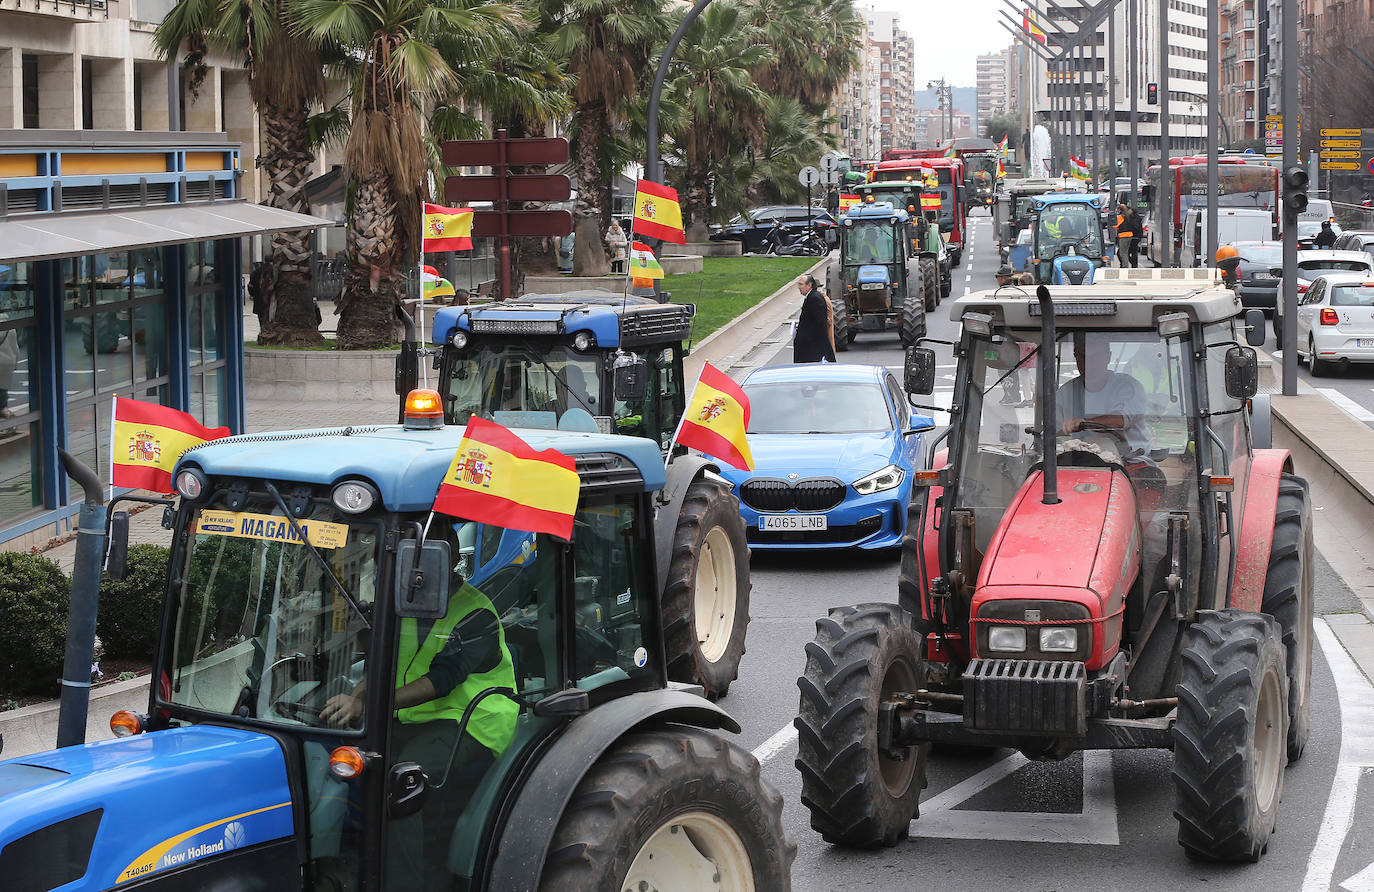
left=826, top=201, right=940, bottom=350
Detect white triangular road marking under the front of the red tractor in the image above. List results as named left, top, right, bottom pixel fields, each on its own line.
left=911, top=750, right=1121, bottom=845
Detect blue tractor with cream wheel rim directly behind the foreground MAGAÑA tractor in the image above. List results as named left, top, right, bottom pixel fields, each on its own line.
left=414, top=291, right=749, bottom=700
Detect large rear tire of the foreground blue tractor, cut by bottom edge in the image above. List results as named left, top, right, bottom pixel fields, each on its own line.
left=539, top=724, right=797, bottom=892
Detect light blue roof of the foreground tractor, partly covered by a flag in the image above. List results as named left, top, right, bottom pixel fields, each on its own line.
left=177, top=425, right=664, bottom=511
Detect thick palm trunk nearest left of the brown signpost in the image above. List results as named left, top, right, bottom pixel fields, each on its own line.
left=338, top=168, right=405, bottom=350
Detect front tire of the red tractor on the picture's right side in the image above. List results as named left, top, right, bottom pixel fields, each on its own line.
left=1173, top=610, right=1287, bottom=862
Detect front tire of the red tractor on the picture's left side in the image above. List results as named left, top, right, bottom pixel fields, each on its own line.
left=796, top=603, right=926, bottom=848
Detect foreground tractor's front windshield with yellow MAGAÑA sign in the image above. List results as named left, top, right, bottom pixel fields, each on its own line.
left=161, top=500, right=382, bottom=727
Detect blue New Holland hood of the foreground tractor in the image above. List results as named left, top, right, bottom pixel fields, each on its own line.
left=0, top=724, right=295, bottom=889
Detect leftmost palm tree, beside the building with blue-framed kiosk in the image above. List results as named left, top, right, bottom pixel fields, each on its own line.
left=154, top=0, right=324, bottom=345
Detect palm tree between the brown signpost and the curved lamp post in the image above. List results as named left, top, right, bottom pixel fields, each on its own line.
left=544, top=0, right=666, bottom=275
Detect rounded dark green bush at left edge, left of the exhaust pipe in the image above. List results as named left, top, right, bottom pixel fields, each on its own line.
left=0, top=551, right=71, bottom=695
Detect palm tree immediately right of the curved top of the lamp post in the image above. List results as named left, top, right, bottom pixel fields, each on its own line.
left=665, top=3, right=772, bottom=242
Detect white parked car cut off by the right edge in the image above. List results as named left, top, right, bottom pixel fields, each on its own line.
left=1297, top=272, right=1374, bottom=378
